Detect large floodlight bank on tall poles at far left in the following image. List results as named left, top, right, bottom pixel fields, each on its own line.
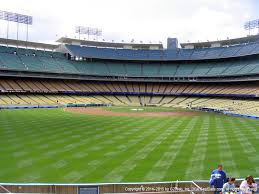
left=0, top=10, right=33, bottom=46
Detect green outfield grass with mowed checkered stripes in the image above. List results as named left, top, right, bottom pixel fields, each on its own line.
left=0, top=107, right=259, bottom=183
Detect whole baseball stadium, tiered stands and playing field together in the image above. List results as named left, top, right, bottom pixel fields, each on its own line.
left=0, top=2, right=259, bottom=194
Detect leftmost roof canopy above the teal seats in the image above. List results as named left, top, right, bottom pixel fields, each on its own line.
left=0, top=38, right=58, bottom=51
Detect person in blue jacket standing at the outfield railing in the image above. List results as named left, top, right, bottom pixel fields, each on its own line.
left=209, top=164, right=227, bottom=194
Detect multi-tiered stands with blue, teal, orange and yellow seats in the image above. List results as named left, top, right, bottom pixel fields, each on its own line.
left=0, top=35, right=259, bottom=118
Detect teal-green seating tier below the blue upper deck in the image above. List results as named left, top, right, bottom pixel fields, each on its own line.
left=0, top=46, right=259, bottom=77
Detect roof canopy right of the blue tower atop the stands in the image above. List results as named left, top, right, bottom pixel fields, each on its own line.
left=180, top=34, right=259, bottom=49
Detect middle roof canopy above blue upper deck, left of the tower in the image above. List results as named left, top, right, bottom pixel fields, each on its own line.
left=56, top=37, right=163, bottom=50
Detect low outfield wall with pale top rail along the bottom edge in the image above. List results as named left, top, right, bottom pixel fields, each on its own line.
left=0, top=178, right=259, bottom=194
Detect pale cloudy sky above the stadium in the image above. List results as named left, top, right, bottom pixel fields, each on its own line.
left=0, top=0, right=259, bottom=46
